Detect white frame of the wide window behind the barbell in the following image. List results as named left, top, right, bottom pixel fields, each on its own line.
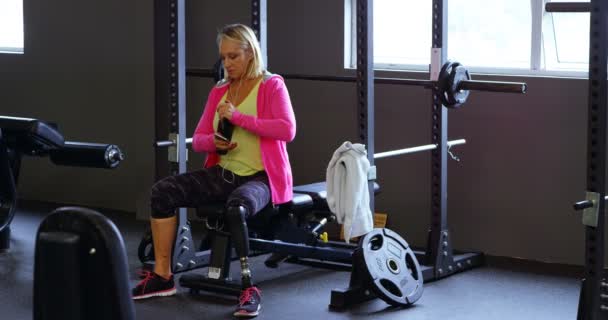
left=344, top=0, right=589, bottom=78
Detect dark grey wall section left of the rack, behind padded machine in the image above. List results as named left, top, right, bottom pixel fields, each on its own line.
left=0, top=0, right=154, bottom=215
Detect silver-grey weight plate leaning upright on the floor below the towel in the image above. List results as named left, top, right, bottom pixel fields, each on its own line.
left=354, top=228, right=423, bottom=306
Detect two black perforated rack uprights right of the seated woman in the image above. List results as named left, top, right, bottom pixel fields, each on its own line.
left=330, top=0, right=484, bottom=308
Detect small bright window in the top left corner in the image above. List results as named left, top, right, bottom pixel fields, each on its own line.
left=0, top=0, right=23, bottom=53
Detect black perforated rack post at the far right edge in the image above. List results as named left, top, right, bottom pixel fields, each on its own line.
left=545, top=0, right=608, bottom=320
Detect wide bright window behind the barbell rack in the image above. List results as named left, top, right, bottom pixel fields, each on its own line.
left=345, top=0, right=589, bottom=76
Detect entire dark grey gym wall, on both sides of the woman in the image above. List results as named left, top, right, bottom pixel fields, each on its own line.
left=0, top=0, right=604, bottom=264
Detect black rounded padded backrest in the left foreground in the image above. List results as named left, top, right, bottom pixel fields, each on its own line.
left=33, top=207, right=135, bottom=320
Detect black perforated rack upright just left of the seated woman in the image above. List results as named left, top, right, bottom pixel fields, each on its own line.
left=154, top=0, right=190, bottom=271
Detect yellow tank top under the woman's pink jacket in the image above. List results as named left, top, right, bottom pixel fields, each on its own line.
left=213, top=81, right=264, bottom=176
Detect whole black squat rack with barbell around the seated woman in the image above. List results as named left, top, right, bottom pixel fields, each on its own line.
left=155, top=0, right=526, bottom=284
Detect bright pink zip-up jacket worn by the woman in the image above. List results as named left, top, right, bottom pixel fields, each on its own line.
left=192, top=73, right=296, bottom=204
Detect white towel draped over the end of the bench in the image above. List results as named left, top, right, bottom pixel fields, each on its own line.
left=326, top=141, right=374, bottom=243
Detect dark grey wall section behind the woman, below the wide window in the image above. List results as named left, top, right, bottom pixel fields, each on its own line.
left=188, top=0, right=604, bottom=264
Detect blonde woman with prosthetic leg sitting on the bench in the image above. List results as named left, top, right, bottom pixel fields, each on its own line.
left=133, top=24, right=296, bottom=317
